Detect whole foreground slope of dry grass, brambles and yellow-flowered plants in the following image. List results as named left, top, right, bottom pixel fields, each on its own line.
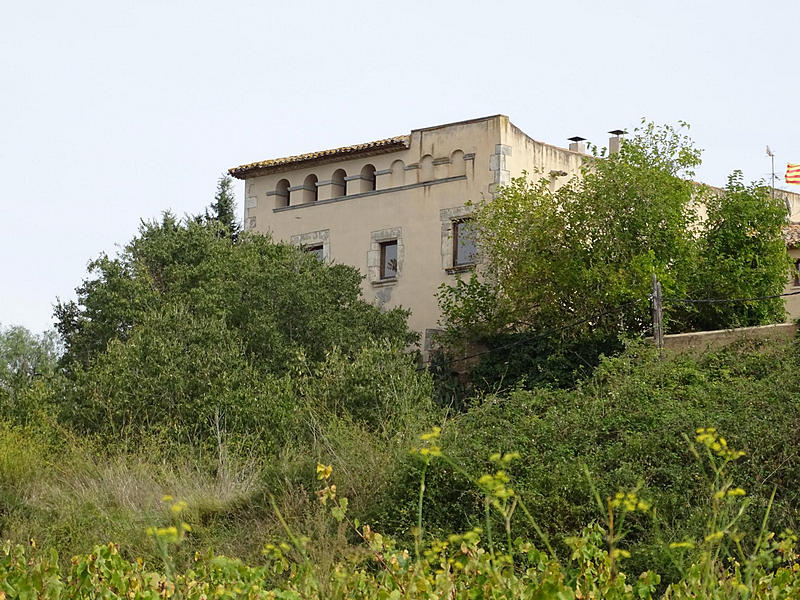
left=0, top=345, right=800, bottom=599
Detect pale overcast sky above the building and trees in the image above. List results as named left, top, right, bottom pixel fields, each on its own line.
left=0, top=0, right=800, bottom=332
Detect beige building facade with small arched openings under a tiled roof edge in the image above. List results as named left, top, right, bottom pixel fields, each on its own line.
left=229, top=115, right=800, bottom=351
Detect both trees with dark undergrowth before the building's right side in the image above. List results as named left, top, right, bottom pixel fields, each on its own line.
left=440, top=123, right=789, bottom=389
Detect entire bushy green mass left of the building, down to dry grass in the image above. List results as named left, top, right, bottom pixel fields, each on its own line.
left=56, top=214, right=424, bottom=451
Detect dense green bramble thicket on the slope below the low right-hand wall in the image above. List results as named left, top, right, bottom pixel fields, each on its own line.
left=374, top=343, right=800, bottom=578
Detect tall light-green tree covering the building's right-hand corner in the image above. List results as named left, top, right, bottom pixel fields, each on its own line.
left=440, top=123, right=700, bottom=368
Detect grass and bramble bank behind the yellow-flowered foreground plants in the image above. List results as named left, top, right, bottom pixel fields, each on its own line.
left=0, top=324, right=800, bottom=593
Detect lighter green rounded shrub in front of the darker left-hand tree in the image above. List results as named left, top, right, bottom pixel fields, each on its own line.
left=62, top=306, right=295, bottom=451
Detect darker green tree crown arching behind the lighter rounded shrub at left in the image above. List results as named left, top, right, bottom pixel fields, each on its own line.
left=55, top=214, right=415, bottom=373
